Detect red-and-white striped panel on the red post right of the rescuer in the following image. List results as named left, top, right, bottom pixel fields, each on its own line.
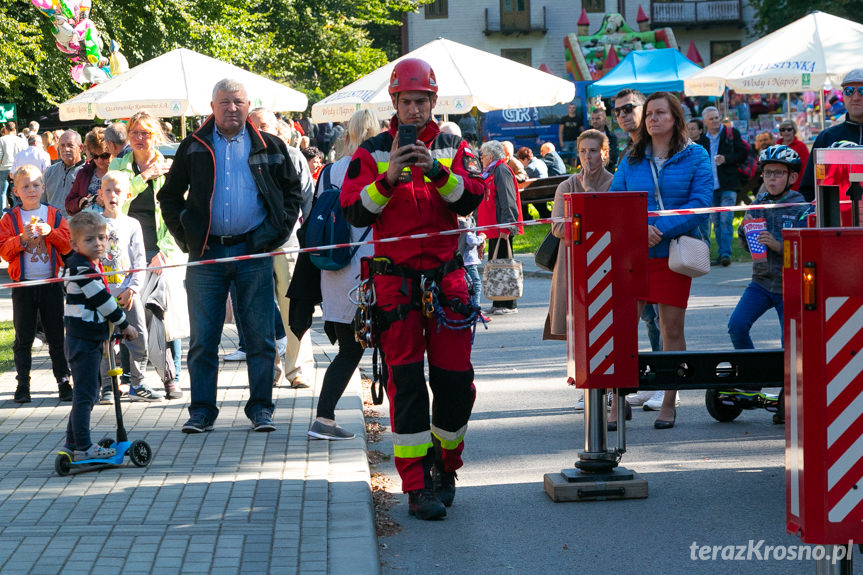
left=585, top=232, right=614, bottom=375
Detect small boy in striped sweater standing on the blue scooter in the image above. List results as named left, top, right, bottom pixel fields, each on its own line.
left=63, top=211, right=138, bottom=461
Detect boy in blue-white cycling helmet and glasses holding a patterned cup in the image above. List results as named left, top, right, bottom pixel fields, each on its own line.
left=728, top=145, right=807, bottom=423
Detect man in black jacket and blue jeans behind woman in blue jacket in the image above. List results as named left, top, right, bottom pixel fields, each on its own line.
left=701, top=106, right=747, bottom=266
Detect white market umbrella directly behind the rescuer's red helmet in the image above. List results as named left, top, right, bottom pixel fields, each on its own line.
left=312, top=38, right=575, bottom=123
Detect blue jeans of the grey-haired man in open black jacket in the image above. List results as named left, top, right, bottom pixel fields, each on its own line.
left=186, top=243, right=276, bottom=421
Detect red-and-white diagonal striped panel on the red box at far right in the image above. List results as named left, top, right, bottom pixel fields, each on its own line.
left=824, top=297, right=863, bottom=523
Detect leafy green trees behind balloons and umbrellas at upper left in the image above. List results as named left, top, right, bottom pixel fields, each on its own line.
left=0, top=0, right=429, bottom=118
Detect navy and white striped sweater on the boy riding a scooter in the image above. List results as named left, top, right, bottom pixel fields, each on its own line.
left=61, top=252, right=129, bottom=340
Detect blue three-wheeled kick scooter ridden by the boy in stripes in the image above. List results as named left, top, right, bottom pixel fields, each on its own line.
left=54, top=326, right=153, bottom=476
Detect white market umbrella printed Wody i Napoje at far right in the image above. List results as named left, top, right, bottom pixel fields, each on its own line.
left=683, top=12, right=863, bottom=96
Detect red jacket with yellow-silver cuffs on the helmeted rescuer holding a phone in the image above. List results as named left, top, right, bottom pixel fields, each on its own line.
left=341, top=116, right=485, bottom=270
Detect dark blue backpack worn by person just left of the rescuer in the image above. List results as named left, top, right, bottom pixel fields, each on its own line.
left=304, top=165, right=371, bottom=271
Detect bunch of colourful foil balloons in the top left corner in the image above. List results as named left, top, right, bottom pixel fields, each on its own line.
left=30, top=0, right=129, bottom=84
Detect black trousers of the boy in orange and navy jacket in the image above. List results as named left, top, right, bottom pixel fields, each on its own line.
left=12, top=283, right=70, bottom=385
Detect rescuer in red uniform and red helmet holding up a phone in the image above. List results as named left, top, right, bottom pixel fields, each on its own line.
left=341, top=59, right=484, bottom=519
